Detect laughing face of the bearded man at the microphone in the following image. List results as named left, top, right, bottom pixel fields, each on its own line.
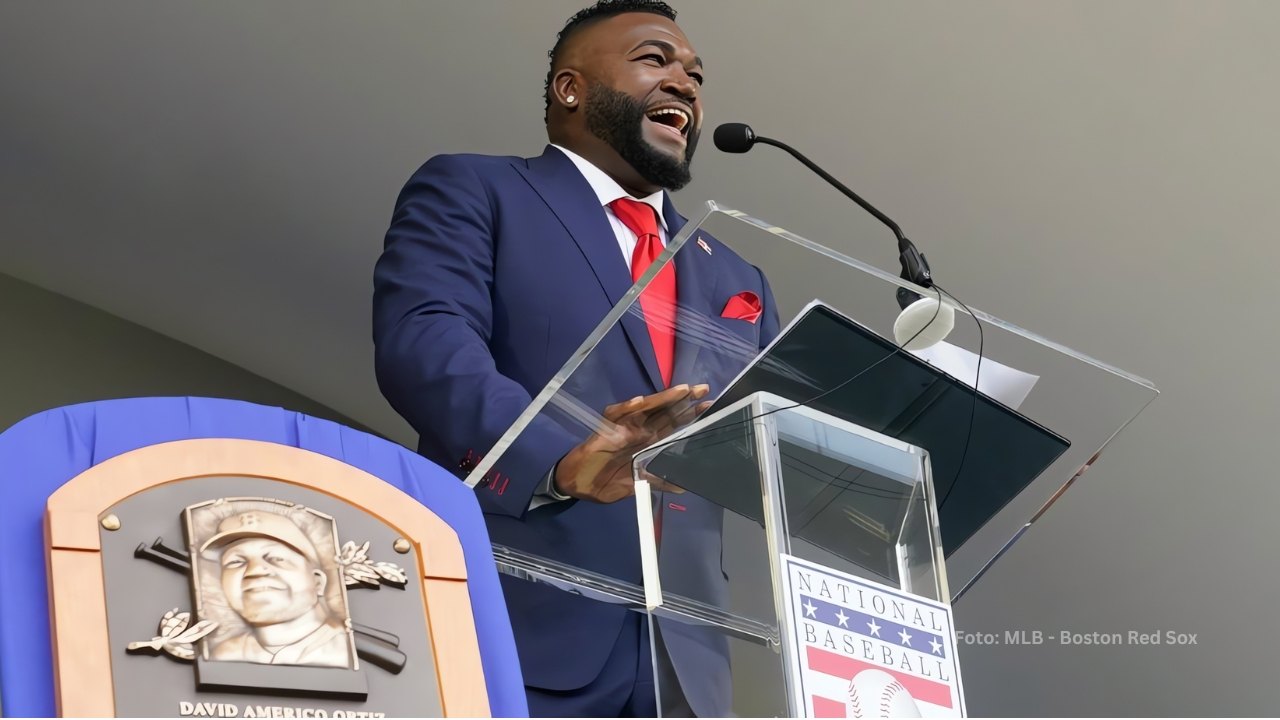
left=581, top=13, right=703, bottom=190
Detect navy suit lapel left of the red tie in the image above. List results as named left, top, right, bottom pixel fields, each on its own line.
left=512, top=146, right=680, bottom=391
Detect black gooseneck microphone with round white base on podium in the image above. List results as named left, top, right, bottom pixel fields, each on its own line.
left=712, top=123, right=955, bottom=350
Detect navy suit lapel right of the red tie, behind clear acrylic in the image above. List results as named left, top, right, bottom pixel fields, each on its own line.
left=663, top=196, right=719, bottom=384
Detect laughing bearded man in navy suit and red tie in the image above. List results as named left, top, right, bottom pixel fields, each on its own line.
left=374, top=0, right=778, bottom=716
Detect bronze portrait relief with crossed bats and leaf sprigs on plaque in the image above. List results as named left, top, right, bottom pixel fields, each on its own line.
left=125, top=484, right=424, bottom=701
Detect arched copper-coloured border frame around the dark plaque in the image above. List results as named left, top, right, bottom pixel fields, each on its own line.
left=45, top=438, right=490, bottom=717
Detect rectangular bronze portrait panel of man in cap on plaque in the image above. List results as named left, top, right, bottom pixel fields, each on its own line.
left=186, top=498, right=357, bottom=669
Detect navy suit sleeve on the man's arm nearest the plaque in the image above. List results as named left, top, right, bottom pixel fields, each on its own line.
left=374, top=155, right=577, bottom=518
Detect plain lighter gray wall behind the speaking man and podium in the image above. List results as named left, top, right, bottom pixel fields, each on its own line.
left=0, top=0, right=1280, bottom=715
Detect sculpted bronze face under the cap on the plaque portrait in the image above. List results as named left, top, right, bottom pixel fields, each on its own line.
left=221, top=538, right=325, bottom=625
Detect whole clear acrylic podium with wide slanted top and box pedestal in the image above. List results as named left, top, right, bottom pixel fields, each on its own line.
left=467, top=202, right=1157, bottom=716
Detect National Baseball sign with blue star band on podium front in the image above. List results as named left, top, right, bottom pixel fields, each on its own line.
left=782, top=555, right=965, bottom=717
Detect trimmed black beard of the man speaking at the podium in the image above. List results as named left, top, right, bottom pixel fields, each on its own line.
left=584, top=83, right=699, bottom=190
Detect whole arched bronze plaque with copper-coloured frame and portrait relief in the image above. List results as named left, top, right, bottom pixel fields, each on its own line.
left=46, top=439, right=489, bottom=717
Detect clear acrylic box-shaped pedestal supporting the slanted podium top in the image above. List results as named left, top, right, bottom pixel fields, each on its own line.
left=634, top=392, right=948, bottom=717
